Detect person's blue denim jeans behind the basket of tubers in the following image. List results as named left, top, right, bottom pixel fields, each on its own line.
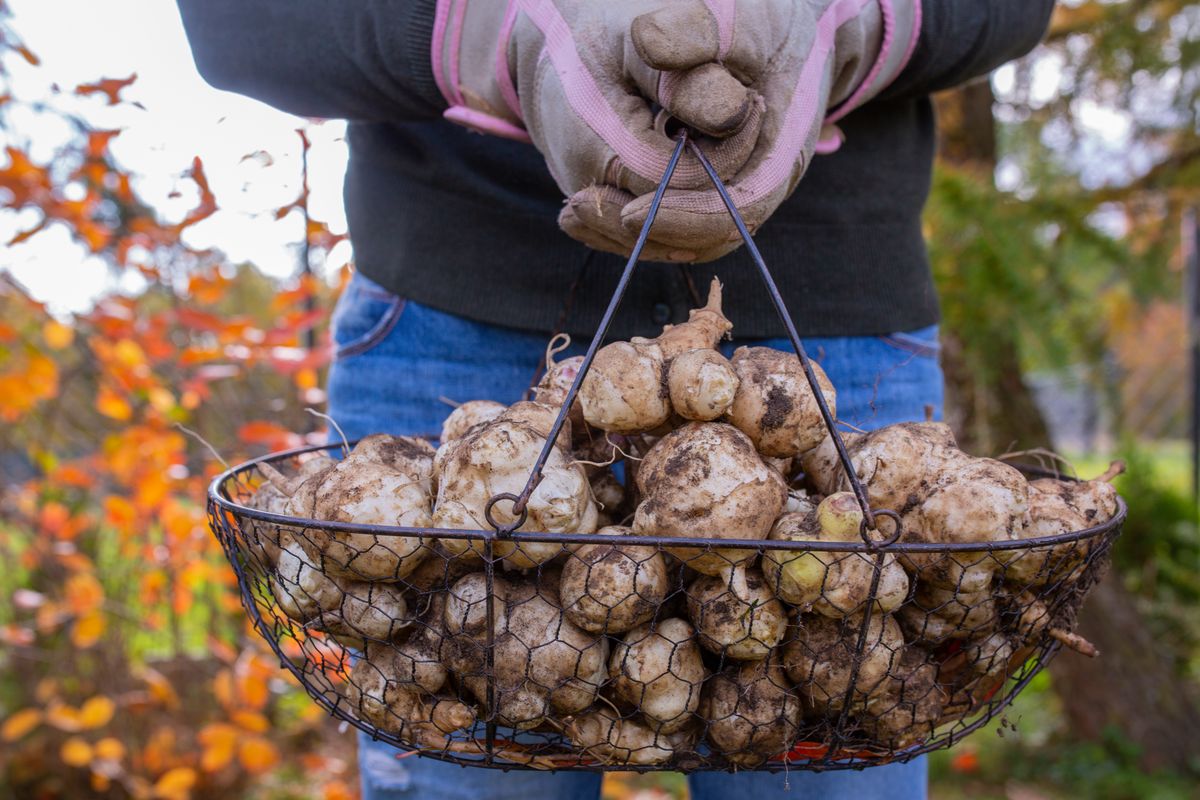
left=329, top=275, right=942, bottom=800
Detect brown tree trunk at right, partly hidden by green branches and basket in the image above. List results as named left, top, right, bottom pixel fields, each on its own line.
left=936, top=82, right=1200, bottom=770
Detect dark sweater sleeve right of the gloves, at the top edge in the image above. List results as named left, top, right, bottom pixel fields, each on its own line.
left=881, top=0, right=1054, bottom=98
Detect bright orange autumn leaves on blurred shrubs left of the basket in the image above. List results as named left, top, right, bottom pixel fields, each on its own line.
left=0, top=2, right=354, bottom=800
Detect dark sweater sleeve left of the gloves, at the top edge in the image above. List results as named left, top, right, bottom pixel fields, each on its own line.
left=178, top=0, right=445, bottom=121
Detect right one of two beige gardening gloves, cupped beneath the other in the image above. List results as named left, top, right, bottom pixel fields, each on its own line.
left=559, top=0, right=920, bottom=261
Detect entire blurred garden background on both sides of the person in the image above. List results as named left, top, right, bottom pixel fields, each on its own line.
left=0, top=0, right=1200, bottom=800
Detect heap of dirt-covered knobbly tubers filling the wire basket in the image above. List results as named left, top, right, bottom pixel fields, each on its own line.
left=240, top=281, right=1118, bottom=769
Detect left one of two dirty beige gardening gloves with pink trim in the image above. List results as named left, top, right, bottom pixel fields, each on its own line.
left=432, top=0, right=763, bottom=260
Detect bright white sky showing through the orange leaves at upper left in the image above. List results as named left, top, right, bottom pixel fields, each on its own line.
left=0, top=0, right=350, bottom=313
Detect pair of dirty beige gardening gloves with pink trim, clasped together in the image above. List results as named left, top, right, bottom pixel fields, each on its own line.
left=432, top=0, right=920, bottom=261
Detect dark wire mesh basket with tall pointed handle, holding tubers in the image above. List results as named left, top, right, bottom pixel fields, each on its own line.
left=209, top=134, right=1126, bottom=771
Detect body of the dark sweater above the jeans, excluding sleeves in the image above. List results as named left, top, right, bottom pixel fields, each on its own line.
left=346, top=100, right=937, bottom=336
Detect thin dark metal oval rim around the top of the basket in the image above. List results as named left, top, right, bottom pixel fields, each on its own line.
left=208, top=443, right=1128, bottom=553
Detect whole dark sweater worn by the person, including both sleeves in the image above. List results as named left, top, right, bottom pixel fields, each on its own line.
left=179, top=0, right=1054, bottom=337
